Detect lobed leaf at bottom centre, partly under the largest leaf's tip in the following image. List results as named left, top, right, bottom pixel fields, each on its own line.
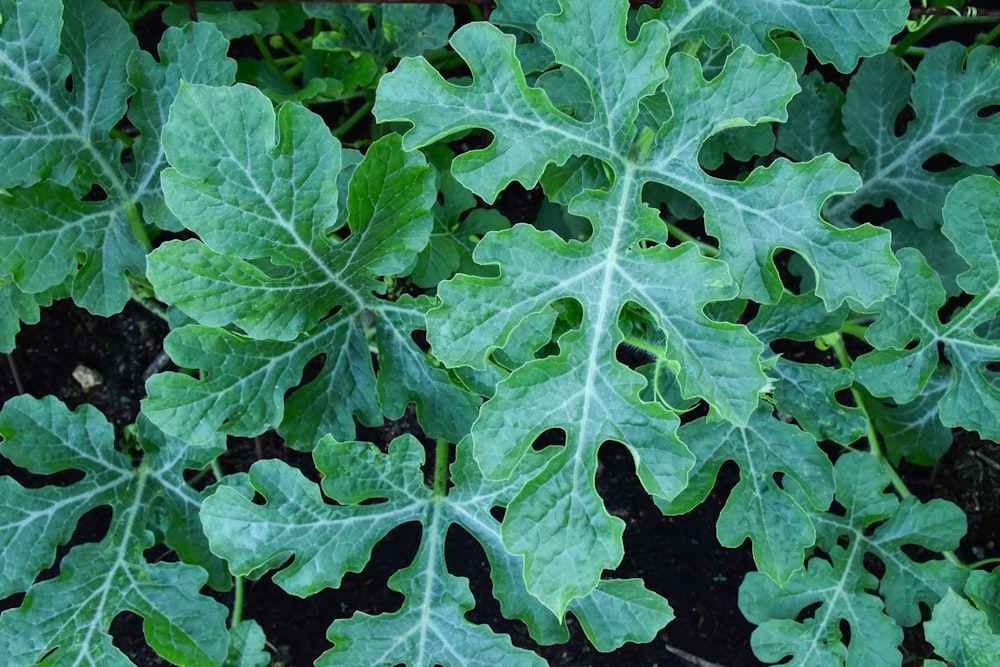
left=202, top=436, right=671, bottom=665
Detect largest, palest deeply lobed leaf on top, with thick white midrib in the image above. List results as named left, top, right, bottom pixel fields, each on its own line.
left=374, top=1, right=897, bottom=614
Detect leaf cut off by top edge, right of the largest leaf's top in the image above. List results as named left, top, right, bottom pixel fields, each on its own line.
left=644, top=0, right=910, bottom=72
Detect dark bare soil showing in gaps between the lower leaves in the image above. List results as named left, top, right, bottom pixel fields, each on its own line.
left=0, top=302, right=1000, bottom=666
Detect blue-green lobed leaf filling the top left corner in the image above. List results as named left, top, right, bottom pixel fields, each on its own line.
left=0, top=0, right=233, bottom=324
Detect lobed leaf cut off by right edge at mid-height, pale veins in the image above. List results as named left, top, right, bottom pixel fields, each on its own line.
left=854, top=176, right=1000, bottom=440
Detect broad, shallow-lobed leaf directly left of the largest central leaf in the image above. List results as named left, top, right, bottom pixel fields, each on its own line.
left=143, top=86, right=478, bottom=449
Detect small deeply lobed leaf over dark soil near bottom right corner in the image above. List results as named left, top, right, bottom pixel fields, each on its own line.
left=739, top=453, right=967, bottom=667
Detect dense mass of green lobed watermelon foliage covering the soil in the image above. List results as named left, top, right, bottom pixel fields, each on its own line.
left=0, top=0, right=1000, bottom=666
